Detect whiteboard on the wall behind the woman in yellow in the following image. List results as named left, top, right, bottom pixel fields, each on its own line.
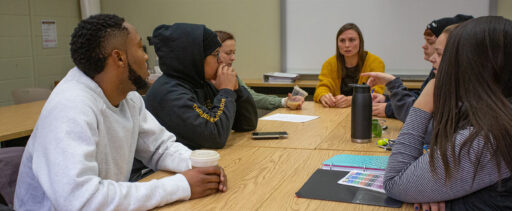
left=281, top=0, right=496, bottom=75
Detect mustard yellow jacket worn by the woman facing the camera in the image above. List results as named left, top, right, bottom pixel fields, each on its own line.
left=313, top=52, right=385, bottom=102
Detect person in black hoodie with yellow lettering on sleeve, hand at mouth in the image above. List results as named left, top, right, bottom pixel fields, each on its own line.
left=144, top=23, right=258, bottom=149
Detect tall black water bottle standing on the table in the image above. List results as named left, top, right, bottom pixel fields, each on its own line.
left=351, top=84, right=372, bottom=143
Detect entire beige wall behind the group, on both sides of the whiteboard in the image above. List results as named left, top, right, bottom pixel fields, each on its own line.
left=0, top=0, right=512, bottom=106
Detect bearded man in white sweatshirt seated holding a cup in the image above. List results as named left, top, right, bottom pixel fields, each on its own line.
left=14, top=14, right=227, bottom=210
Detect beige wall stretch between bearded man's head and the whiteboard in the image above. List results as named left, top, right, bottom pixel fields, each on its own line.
left=101, top=0, right=281, bottom=78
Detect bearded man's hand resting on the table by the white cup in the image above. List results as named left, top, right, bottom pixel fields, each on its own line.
left=181, top=166, right=227, bottom=199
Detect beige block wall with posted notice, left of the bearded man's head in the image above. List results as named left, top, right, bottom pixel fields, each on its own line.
left=0, top=0, right=80, bottom=106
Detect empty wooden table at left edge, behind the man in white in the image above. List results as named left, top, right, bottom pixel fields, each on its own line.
left=0, top=100, right=46, bottom=142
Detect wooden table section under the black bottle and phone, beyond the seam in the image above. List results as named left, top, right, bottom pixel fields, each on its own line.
left=226, top=101, right=402, bottom=152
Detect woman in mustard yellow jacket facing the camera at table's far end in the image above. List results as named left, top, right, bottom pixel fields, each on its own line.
left=314, top=23, right=384, bottom=108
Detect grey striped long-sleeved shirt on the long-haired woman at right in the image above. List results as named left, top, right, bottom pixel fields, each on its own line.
left=384, top=107, right=510, bottom=203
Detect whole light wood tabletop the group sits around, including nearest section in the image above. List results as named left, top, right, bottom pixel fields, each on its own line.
left=141, top=102, right=413, bottom=210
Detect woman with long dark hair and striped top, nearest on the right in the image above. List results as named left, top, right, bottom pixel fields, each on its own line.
left=384, top=17, right=512, bottom=210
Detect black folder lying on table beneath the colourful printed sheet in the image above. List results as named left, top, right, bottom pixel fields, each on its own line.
left=295, top=169, right=402, bottom=208
